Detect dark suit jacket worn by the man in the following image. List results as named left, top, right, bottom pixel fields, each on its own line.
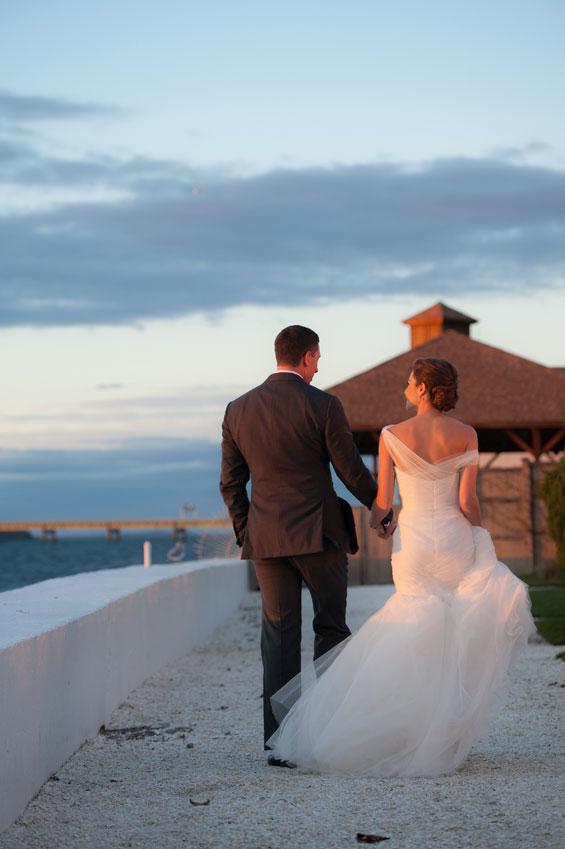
left=220, top=372, right=377, bottom=560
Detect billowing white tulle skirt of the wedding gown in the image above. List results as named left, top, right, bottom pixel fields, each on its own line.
left=267, top=528, right=535, bottom=776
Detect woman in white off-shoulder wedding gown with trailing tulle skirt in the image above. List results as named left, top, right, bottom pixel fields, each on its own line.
left=267, top=358, right=535, bottom=776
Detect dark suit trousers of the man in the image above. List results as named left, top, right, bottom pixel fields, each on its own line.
left=253, top=541, right=351, bottom=748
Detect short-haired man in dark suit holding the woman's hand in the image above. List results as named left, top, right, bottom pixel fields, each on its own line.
left=220, top=325, right=392, bottom=767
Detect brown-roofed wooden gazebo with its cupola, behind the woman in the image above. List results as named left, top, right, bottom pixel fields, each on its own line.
left=328, top=303, right=565, bottom=460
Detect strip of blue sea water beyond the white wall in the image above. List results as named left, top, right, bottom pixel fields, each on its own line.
left=0, top=528, right=239, bottom=592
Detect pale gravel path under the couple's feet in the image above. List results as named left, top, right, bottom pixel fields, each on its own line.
left=0, top=586, right=565, bottom=849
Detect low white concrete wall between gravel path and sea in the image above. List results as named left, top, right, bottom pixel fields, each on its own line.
left=0, top=560, right=247, bottom=829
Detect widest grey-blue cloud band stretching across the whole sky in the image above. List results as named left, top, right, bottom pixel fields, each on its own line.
left=0, top=110, right=565, bottom=326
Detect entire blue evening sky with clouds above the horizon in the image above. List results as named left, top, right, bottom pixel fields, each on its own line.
left=0, top=0, right=565, bottom=519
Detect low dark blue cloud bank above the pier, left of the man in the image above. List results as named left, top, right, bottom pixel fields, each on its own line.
left=0, top=439, right=225, bottom=521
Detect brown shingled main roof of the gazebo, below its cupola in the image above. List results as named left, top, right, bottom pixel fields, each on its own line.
left=328, top=324, right=565, bottom=433
